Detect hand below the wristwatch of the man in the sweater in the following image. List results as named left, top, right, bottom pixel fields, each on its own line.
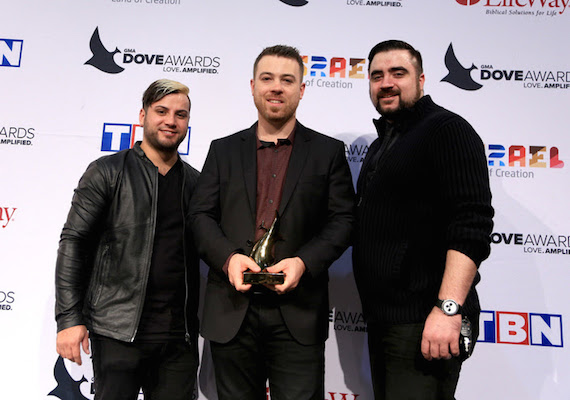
left=421, top=307, right=461, bottom=361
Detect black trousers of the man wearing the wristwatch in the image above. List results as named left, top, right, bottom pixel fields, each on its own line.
left=368, top=323, right=468, bottom=400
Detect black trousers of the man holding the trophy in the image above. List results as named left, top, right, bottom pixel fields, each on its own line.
left=210, top=295, right=325, bottom=400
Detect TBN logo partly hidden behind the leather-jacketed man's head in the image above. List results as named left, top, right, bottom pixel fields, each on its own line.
left=101, top=122, right=191, bottom=156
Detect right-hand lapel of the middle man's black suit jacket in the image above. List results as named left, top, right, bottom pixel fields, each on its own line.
left=279, top=121, right=311, bottom=215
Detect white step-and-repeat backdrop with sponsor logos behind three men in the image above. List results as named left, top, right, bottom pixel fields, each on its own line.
left=0, top=0, right=570, bottom=400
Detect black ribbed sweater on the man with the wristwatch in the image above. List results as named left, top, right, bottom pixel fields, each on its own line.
left=353, top=96, right=493, bottom=324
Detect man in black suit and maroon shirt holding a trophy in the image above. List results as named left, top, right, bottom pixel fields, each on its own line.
left=191, top=46, right=354, bottom=400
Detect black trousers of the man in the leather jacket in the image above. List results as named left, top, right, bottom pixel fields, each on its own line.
left=91, top=335, right=198, bottom=400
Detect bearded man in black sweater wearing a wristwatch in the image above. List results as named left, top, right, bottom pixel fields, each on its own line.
left=353, top=40, right=494, bottom=400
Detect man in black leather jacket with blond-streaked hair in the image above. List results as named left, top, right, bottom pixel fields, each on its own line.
left=55, top=79, right=199, bottom=400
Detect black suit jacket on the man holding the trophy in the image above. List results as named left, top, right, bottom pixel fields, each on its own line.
left=191, top=122, right=354, bottom=344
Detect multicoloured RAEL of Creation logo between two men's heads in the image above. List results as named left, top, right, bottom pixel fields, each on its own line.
left=302, top=55, right=368, bottom=89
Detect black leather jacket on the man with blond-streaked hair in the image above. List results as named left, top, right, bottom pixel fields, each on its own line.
left=55, top=143, right=199, bottom=341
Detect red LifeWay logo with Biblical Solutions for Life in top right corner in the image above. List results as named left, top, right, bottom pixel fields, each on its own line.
left=455, top=0, right=570, bottom=17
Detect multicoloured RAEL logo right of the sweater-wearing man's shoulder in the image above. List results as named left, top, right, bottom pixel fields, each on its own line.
left=487, top=144, right=565, bottom=178
